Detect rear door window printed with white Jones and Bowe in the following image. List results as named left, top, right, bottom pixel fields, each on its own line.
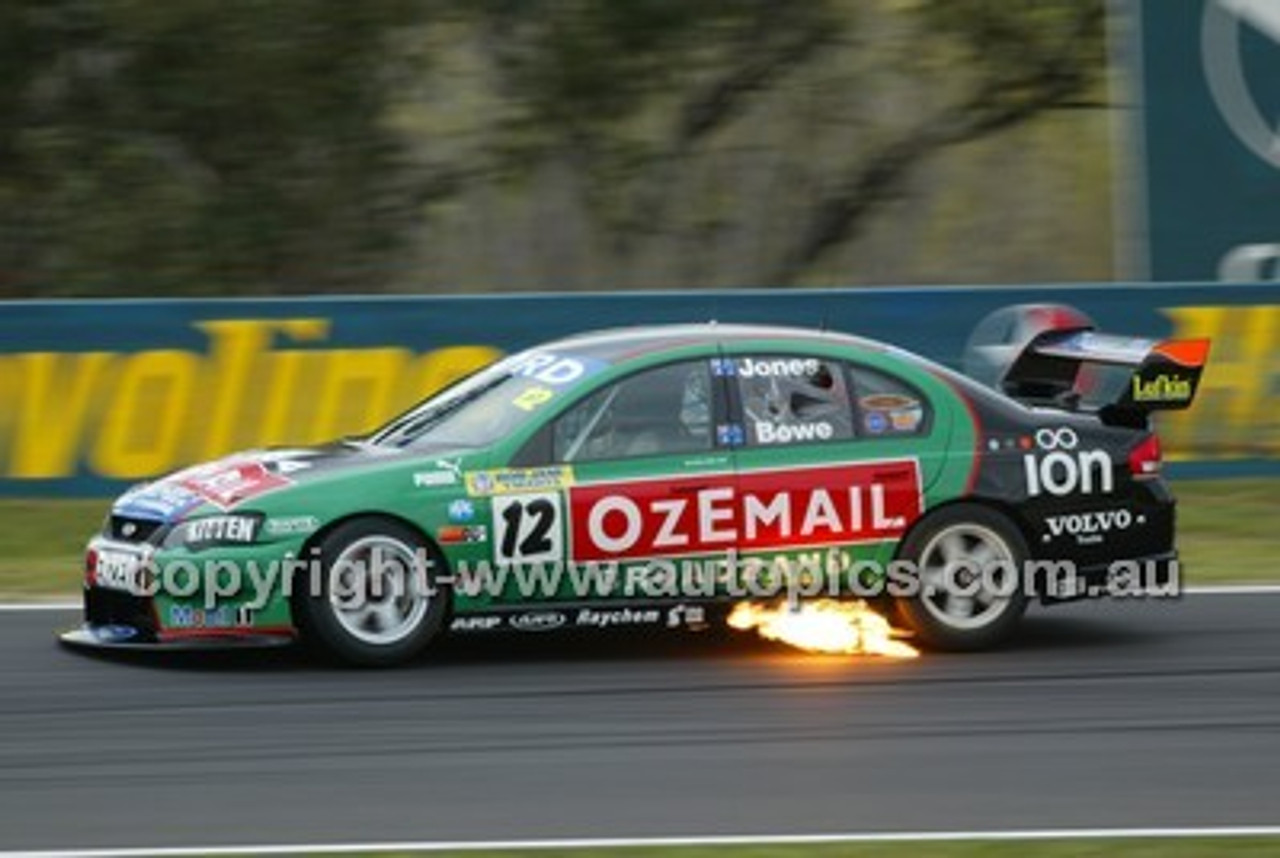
left=728, top=355, right=854, bottom=447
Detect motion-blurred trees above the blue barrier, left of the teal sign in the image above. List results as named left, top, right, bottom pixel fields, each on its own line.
left=0, top=0, right=1112, bottom=297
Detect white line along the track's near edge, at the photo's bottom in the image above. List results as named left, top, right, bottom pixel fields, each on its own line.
left=0, top=825, right=1280, bottom=858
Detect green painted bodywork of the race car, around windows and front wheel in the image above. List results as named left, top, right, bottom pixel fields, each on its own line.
left=124, top=337, right=977, bottom=630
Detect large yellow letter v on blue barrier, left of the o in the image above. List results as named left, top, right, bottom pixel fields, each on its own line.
left=9, top=352, right=114, bottom=479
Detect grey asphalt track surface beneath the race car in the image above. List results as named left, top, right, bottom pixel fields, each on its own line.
left=0, top=594, right=1280, bottom=849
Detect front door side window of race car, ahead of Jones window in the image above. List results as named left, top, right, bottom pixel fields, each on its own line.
left=552, top=360, right=712, bottom=462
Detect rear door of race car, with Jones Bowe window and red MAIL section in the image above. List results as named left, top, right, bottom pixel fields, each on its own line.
left=723, top=351, right=933, bottom=594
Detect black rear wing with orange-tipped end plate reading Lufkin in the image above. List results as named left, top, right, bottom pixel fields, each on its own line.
left=1001, top=328, right=1210, bottom=423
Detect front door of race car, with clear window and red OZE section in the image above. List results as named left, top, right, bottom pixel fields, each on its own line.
left=494, top=356, right=736, bottom=612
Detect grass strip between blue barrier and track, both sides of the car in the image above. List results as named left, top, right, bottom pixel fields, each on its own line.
left=0, top=479, right=1280, bottom=598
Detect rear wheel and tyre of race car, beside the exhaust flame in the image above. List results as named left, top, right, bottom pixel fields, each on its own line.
left=897, top=503, right=1028, bottom=651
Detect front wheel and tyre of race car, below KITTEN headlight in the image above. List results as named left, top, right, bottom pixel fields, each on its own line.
left=296, top=519, right=449, bottom=667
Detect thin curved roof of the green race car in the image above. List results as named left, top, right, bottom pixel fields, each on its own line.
left=543, top=321, right=888, bottom=362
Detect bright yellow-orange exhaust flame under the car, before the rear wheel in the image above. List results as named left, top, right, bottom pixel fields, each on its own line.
left=728, top=599, right=920, bottom=658
